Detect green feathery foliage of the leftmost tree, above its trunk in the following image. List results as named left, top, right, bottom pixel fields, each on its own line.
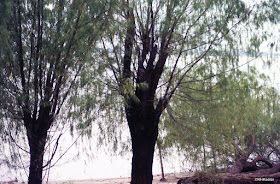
left=0, top=0, right=113, bottom=175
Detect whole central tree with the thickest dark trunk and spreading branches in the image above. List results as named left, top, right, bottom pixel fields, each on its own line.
left=102, top=0, right=278, bottom=184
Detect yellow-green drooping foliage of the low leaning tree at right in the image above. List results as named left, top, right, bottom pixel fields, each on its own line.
left=164, top=68, right=280, bottom=168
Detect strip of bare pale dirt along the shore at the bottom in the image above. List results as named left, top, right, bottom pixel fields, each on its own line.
left=0, top=173, right=192, bottom=184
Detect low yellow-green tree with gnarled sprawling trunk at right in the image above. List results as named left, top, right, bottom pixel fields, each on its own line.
left=165, top=64, right=280, bottom=183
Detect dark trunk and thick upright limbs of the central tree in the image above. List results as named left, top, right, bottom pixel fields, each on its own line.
left=120, top=1, right=167, bottom=184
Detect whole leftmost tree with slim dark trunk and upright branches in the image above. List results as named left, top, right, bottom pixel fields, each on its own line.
left=0, top=0, right=111, bottom=184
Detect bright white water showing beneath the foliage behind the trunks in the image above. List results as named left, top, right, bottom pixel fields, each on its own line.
left=0, top=122, right=187, bottom=181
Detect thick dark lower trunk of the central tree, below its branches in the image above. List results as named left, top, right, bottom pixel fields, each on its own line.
left=127, top=103, right=159, bottom=184
